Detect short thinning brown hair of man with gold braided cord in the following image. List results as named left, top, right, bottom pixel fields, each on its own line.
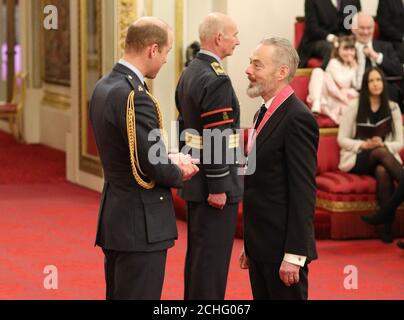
left=125, top=17, right=170, bottom=53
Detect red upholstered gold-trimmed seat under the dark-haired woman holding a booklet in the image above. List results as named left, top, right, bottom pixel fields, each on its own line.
left=316, top=133, right=404, bottom=239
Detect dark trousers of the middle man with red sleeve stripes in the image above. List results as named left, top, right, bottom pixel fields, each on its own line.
left=184, top=202, right=238, bottom=300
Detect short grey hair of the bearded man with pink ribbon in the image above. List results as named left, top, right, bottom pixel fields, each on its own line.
left=261, top=37, right=300, bottom=83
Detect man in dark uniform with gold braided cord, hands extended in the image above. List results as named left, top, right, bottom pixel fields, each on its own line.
left=90, top=17, right=198, bottom=300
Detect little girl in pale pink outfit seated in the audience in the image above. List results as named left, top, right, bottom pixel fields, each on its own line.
left=307, top=36, right=358, bottom=124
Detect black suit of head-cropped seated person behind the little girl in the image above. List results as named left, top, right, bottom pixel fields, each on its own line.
left=298, top=0, right=362, bottom=66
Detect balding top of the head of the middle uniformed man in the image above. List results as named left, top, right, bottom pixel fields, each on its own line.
left=199, top=12, right=236, bottom=44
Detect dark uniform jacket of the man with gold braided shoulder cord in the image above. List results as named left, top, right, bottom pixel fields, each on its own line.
left=90, top=64, right=183, bottom=252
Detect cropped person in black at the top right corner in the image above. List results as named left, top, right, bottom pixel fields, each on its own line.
left=377, top=0, right=404, bottom=64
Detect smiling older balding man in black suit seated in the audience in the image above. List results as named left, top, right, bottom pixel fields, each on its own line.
left=352, top=13, right=404, bottom=112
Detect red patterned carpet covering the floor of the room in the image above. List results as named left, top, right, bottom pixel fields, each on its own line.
left=0, top=132, right=404, bottom=300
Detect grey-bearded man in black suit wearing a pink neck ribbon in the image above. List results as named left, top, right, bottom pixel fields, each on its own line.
left=240, top=38, right=319, bottom=300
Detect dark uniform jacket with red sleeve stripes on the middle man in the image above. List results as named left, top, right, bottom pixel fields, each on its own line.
left=176, top=53, right=243, bottom=203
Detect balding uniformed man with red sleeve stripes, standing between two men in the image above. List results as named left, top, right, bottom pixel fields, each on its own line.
left=176, top=13, right=242, bottom=299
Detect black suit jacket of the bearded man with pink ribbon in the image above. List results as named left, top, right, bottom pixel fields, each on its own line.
left=244, top=95, right=319, bottom=263
